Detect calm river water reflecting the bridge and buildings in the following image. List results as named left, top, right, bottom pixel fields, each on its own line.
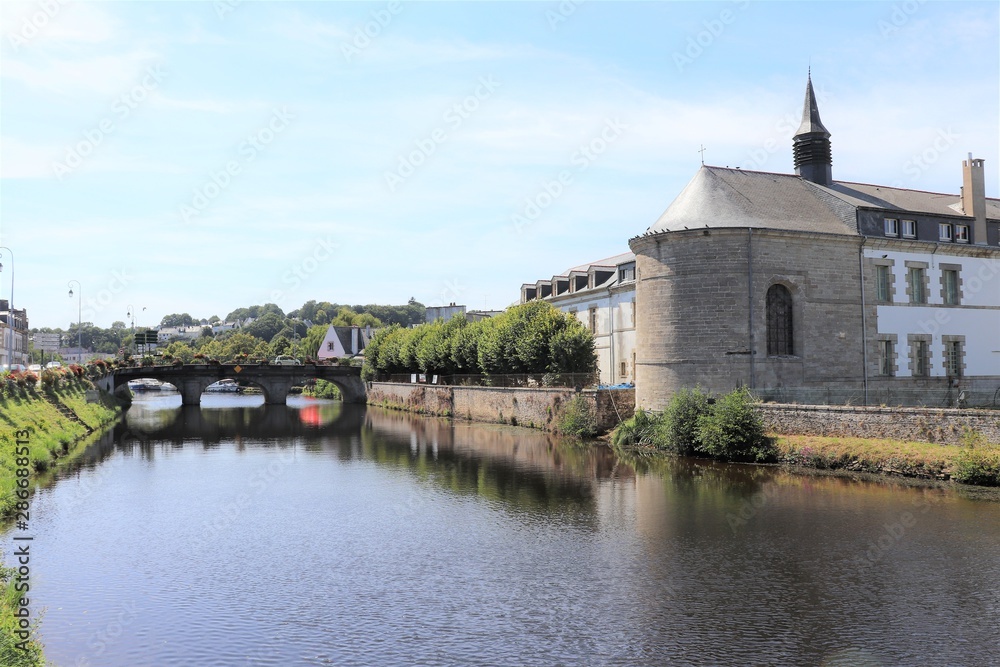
left=11, top=395, right=1000, bottom=667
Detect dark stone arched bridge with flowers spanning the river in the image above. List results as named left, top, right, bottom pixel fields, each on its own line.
left=109, top=364, right=366, bottom=405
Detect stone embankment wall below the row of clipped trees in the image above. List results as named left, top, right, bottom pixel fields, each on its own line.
left=368, top=382, right=635, bottom=431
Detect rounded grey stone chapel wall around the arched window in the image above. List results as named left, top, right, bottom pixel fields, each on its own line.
left=633, top=228, right=863, bottom=410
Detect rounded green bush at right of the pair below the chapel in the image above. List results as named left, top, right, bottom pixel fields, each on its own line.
left=694, top=389, right=777, bottom=462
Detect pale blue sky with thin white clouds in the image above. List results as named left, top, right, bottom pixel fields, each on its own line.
left=0, top=0, right=1000, bottom=327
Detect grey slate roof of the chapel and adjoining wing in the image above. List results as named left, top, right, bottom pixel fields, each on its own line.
left=647, top=166, right=1000, bottom=236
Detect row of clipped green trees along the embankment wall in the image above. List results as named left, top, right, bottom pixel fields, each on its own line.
left=362, top=301, right=597, bottom=379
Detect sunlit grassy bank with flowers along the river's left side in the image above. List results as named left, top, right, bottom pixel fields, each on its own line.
left=0, top=373, right=122, bottom=667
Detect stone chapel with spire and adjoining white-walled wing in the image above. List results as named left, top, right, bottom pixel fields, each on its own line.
left=628, top=73, right=1000, bottom=409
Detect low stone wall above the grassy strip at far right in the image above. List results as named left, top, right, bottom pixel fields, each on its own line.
left=761, top=403, right=1000, bottom=445
